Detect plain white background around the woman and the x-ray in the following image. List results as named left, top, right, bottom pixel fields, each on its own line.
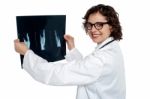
left=0, top=0, right=150, bottom=99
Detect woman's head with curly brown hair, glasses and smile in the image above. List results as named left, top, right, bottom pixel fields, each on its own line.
left=83, top=3, right=122, bottom=43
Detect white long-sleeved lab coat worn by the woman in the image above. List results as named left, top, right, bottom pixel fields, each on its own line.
left=23, top=38, right=125, bottom=99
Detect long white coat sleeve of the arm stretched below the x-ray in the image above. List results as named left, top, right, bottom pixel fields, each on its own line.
left=23, top=50, right=104, bottom=85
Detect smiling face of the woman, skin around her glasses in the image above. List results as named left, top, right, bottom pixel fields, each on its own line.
left=87, top=12, right=111, bottom=44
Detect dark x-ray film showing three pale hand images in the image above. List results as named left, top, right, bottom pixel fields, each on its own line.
left=16, top=15, right=66, bottom=68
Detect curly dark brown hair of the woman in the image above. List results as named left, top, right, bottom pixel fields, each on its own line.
left=83, top=4, right=122, bottom=40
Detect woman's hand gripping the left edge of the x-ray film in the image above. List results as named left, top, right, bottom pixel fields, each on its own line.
left=14, top=39, right=29, bottom=55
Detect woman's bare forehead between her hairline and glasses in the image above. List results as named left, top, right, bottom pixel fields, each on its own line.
left=88, top=12, right=107, bottom=23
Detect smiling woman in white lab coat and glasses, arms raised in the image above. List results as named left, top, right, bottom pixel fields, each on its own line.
left=14, top=4, right=125, bottom=99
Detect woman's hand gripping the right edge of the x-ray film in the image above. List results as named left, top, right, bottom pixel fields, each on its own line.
left=64, top=35, right=75, bottom=50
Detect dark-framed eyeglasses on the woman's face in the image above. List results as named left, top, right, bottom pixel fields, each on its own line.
left=84, top=22, right=108, bottom=30
